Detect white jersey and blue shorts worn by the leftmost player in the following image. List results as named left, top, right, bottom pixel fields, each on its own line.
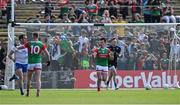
left=12, top=45, right=28, bottom=72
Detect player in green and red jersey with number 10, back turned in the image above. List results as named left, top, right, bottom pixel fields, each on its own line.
left=18, top=33, right=50, bottom=97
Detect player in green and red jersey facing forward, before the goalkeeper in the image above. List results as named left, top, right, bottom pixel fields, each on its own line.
left=93, top=38, right=113, bottom=91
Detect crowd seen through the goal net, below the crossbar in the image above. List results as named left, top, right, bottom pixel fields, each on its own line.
left=42, top=26, right=180, bottom=70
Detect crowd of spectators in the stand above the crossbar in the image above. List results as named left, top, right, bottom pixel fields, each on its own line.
left=0, top=0, right=180, bottom=23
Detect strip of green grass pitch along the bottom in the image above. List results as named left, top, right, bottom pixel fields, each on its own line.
left=0, top=89, right=180, bottom=104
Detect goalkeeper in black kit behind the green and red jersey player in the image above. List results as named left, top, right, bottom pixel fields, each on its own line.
left=106, top=38, right=121, bottom=90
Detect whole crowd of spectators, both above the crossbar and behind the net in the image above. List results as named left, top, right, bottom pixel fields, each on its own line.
left=0, top=0, right=180, bottom=84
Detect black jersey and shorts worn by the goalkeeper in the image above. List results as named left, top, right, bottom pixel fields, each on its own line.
left=108, top=45, right=121, bottom=67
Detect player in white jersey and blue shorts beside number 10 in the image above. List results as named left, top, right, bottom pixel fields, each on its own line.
left=8, top=34, right=28, bottom=95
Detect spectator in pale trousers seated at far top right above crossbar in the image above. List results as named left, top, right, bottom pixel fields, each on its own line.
left=161, top=0, right=176, bottom=23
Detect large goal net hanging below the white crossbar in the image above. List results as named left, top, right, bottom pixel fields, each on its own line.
left=5, top=23, right=180, bottom=88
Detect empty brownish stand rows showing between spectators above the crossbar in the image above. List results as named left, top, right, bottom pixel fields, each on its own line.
left=0, top=0, right=180, bottom=40
